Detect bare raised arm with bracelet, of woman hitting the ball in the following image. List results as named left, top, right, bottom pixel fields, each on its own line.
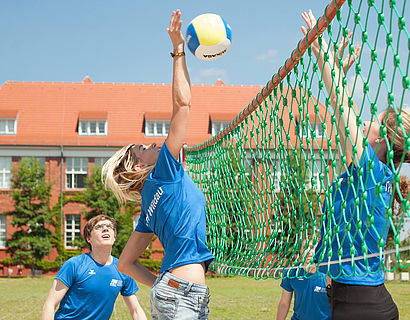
left=166, top=10, right=191, bottom=159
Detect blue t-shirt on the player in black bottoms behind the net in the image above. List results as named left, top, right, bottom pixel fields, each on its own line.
left=315, top=145, right=394, bottom=286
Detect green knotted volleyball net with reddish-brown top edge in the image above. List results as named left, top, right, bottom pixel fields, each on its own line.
left=186, top=0, right=410, bottom=278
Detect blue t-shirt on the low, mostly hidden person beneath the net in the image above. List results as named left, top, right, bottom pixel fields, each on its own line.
left=280, top=269, right=330, bottom=320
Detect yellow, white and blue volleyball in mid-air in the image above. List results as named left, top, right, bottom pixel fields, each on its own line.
left=186, top=13, right=232, bottom=60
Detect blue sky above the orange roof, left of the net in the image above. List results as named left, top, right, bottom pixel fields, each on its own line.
left=0, top=0, right=330, bottom=85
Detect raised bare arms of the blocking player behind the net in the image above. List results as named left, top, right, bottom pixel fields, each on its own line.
left=301, top=10, right=363, bottom=166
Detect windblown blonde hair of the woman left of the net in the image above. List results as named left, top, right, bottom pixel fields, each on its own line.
left=101, top=144, right=155, bottom=204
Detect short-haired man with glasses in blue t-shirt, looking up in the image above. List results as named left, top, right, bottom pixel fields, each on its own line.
left=41, top=215, right=147, bottom=320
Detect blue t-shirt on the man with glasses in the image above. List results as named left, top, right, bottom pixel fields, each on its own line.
left=54, top=253, right=138, bottom=320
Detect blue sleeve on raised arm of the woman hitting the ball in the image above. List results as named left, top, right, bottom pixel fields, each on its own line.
left=152, top=142, right=184, bottom=182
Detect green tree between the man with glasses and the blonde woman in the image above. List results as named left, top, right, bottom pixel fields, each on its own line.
left=82, top=167, right=140, bottom=258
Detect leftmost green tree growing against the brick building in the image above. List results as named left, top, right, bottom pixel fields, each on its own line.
left=7, top=158, right=53, bottom=266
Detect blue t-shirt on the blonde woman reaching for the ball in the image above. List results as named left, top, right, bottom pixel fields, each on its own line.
left=135, top=143, right=214, bottom=272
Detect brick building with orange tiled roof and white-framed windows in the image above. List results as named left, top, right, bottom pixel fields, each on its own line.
left=0, top=77, right=261, bottom=276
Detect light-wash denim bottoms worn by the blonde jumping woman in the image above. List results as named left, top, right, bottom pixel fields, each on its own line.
left=151, top=272, right=209, bottom=320
